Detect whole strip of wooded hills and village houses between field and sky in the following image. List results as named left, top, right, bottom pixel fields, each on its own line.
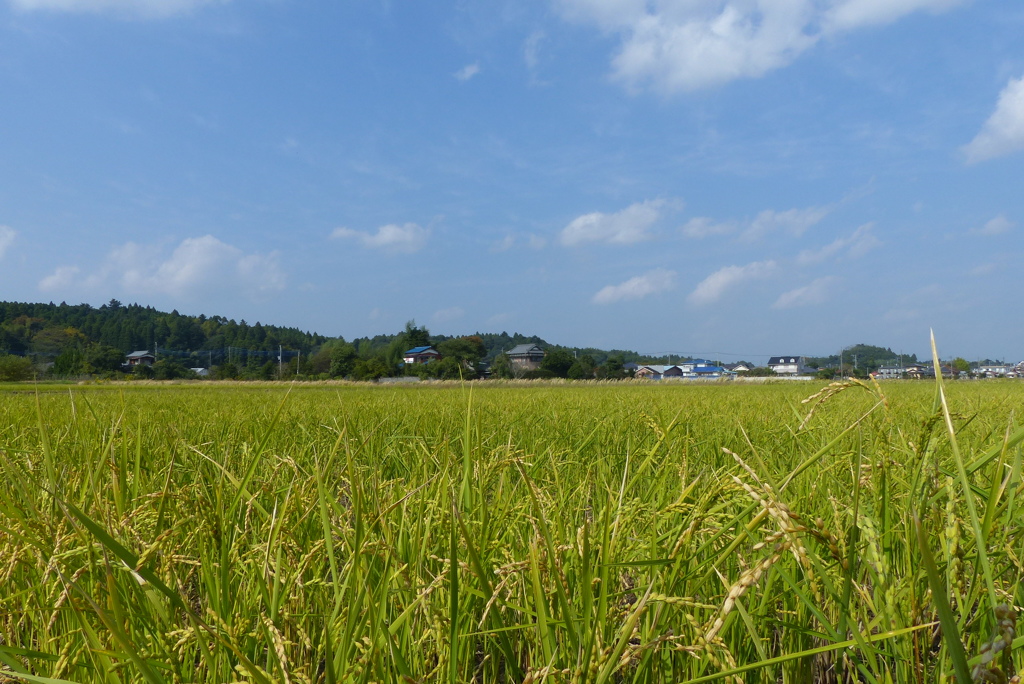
left=0, top=300, right=1024, bottom=382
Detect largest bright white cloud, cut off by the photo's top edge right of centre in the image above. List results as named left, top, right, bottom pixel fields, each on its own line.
left=555, top=0, right=962, bottom=92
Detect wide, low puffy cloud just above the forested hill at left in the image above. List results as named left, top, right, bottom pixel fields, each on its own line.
left=39, top=236, right=286, bottom=297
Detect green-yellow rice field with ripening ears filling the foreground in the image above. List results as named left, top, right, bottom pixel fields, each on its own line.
left=0, top=381, right=1024, bottom=684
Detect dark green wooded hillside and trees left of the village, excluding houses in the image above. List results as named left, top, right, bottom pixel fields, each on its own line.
left=0, top=299, right=642, bottom=380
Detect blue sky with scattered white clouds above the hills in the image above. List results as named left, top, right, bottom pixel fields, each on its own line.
left=0, top=0, right=1024, bottom=361
